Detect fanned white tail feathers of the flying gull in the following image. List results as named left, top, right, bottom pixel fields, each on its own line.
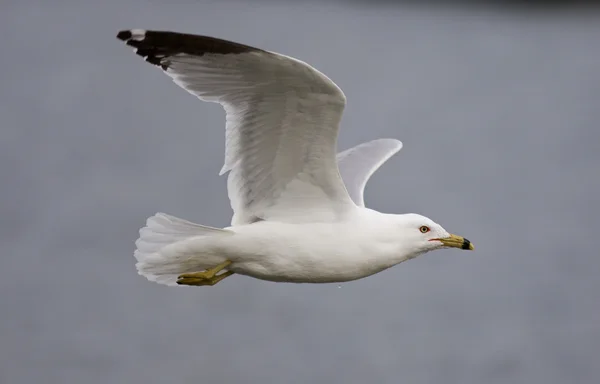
left=133, top=213, right=233, bottom=285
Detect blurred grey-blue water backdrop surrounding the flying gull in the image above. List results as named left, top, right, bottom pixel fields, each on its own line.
left=0, top=0, right=600, bottom=384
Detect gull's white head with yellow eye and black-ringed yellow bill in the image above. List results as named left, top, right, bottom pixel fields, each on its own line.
left=397, top=213, right=475, bottom=257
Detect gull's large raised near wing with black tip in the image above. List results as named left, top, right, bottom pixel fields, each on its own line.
left=117, top=29, right=355, bottom=225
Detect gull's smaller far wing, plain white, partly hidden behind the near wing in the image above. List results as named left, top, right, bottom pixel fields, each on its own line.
left=337, top=139, right=402, bottom=207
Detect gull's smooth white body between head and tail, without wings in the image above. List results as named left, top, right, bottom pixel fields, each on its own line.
left=149, top=208, right=428, bottom=283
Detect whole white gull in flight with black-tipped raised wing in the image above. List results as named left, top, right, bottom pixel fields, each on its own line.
left=117, top=29, right=474, bottom=286
